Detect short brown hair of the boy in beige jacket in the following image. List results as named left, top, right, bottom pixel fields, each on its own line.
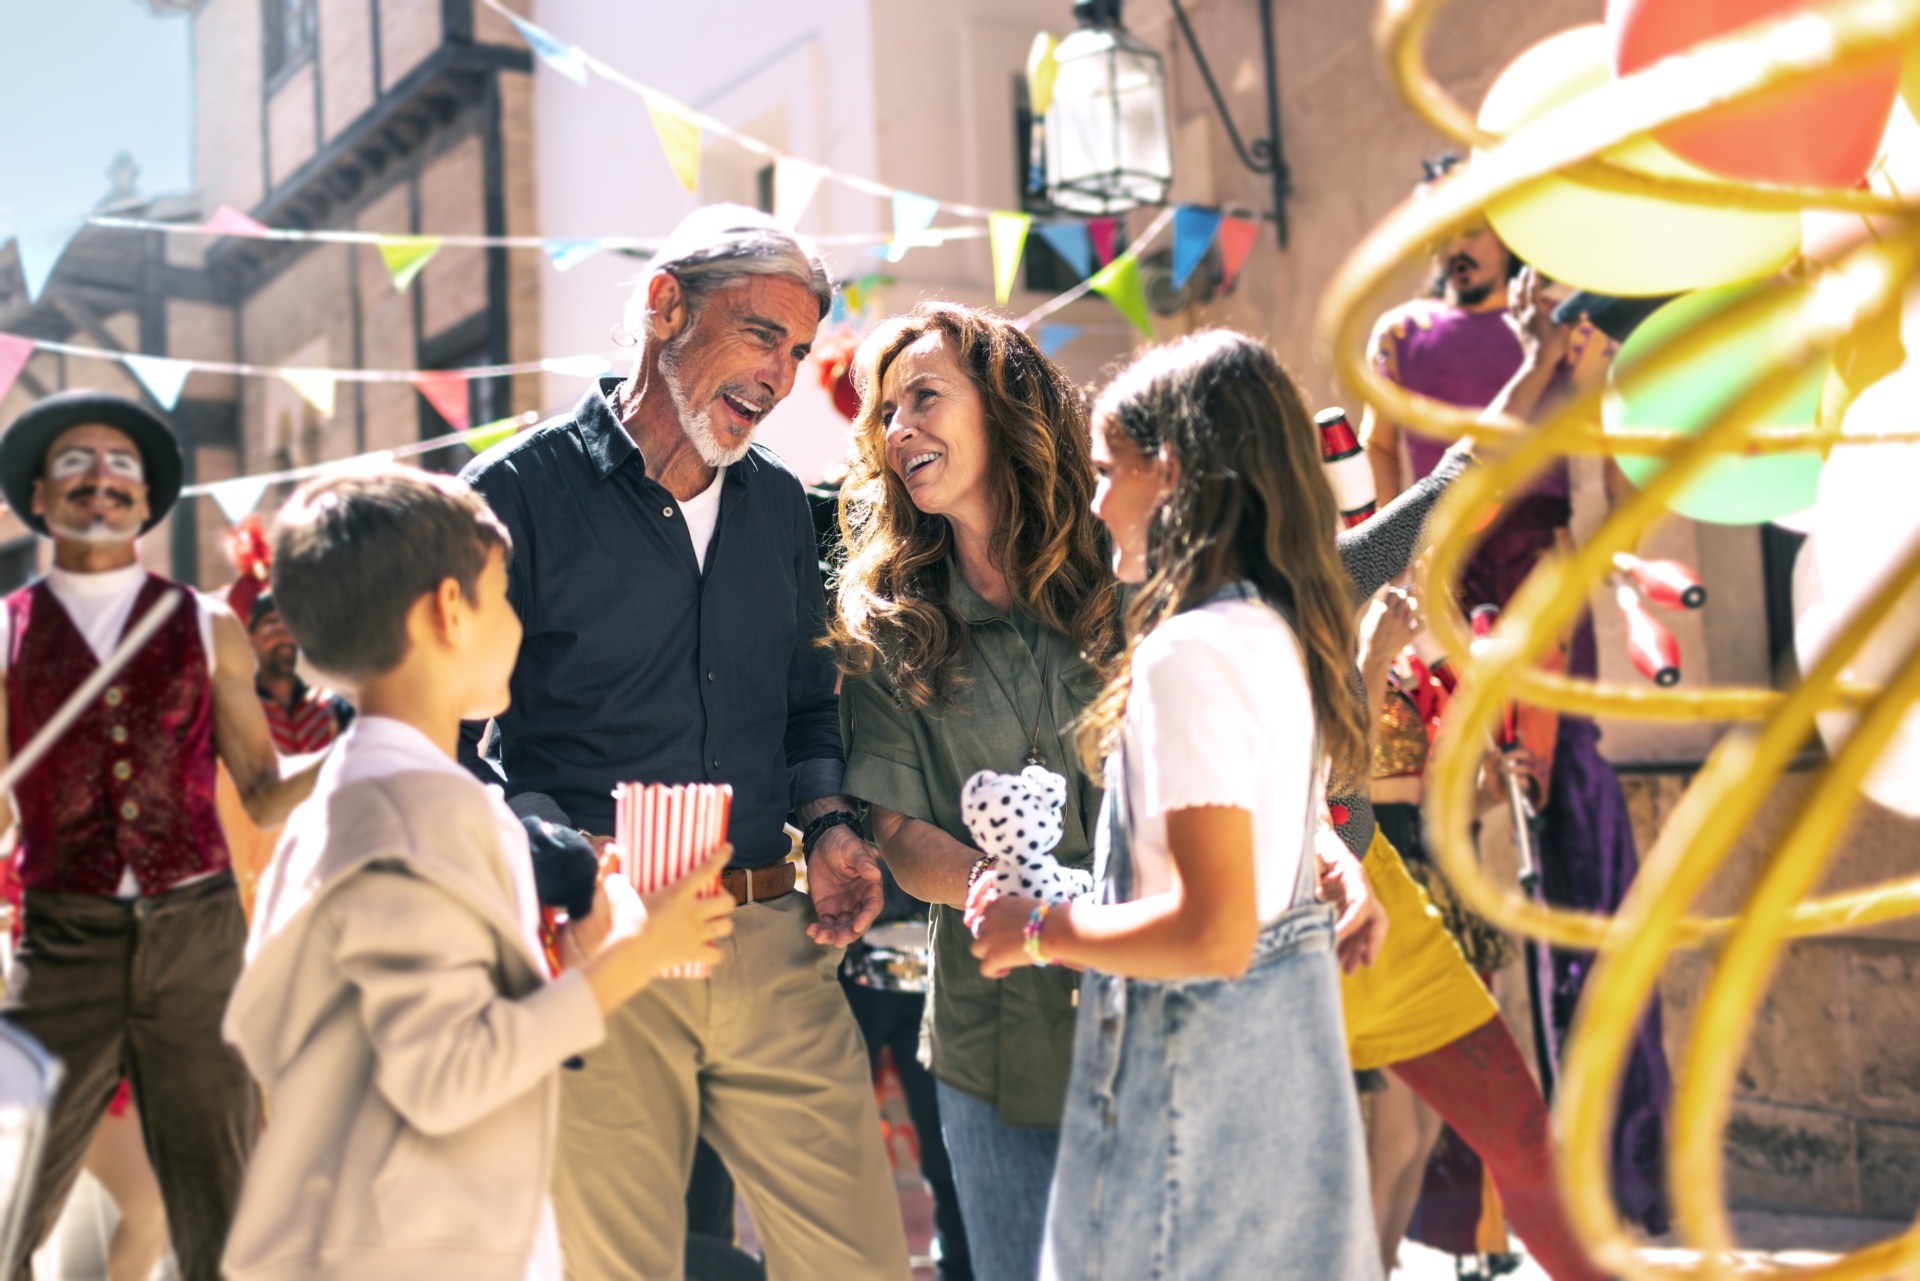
left=273, top=467, right=513, bottom=678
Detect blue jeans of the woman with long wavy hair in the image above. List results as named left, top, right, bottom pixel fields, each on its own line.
left=939, top=1083, right=1060, bottom=1281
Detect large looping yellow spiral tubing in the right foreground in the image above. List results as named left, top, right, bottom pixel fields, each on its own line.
left=1321, top=0, right=1920, bottom=1281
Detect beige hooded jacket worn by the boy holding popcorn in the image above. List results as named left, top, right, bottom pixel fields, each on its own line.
left=223, top=770, right=605, bottom=1281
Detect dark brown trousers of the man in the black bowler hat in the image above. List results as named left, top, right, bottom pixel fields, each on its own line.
left=0, top=874, right=259, bottom=1281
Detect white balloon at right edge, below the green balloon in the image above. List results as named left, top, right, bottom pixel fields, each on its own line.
left=1793, top=365, right=1920, bottom=816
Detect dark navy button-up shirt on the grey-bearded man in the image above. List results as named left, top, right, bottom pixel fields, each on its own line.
left=461, top=378, right=845, bottom=868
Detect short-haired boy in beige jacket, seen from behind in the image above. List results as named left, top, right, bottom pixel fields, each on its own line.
left=225, top=469, right=732, bottom=1281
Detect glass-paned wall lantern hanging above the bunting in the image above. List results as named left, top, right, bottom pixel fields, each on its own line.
left=1046, top=0, right=1173, bottom=215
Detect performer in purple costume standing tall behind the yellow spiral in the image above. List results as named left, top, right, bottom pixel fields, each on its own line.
left=1361, top=161, right=1672, bottom=1233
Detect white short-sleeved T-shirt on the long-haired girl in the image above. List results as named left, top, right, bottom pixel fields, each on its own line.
left=1123, top=599, right=1325, bottom=924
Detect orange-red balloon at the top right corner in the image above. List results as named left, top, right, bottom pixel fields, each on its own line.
left=1607, top=0, right=1901, bottom=186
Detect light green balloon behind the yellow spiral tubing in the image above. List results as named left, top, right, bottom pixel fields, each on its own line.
left=1601, top=282, right=1830, bottom=524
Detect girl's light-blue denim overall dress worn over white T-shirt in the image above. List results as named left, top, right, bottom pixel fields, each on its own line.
left=1041, top=586, right=1380, bottom=1281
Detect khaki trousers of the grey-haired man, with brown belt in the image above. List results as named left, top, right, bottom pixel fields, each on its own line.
left=553, top=893, right=908, bottom=1281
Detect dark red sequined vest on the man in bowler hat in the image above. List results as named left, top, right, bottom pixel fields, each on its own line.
left=6, top=574, right=230, bottom=895
